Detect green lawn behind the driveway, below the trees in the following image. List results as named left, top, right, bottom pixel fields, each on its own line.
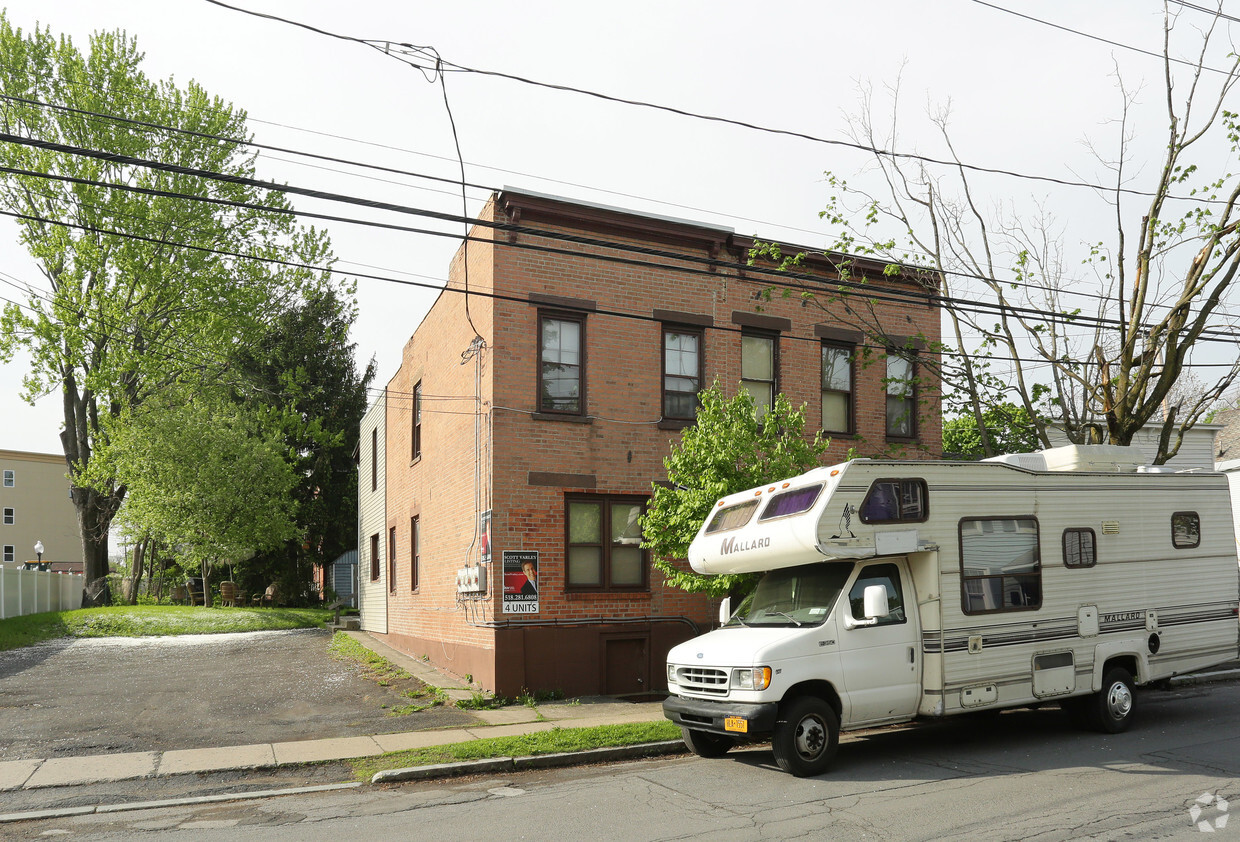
left=0, top=605, right=331, bottom=651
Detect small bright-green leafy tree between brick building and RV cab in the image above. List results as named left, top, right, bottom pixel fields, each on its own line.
left=641, top=383, right=830, bottom=596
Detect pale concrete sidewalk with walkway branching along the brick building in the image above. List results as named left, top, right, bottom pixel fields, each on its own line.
left=0, top=631, right=663, bottom=791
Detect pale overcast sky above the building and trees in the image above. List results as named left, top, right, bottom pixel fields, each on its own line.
left=0, top=0, right=1240, bottom=453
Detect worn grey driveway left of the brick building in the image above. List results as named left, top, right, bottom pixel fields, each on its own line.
left=0, top=629, right=476, bottom=760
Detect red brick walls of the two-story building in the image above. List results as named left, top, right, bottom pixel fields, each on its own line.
left=376, top=192, right=941, bottom=694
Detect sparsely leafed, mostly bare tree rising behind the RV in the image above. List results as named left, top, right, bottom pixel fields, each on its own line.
left=755, top=4, right=1240, bottom=463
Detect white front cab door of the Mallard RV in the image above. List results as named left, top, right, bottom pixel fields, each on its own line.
left=839, top=558, right=921, bottom=725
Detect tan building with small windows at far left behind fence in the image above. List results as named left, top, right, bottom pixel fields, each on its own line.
left=0, top=450, right=84, bottom=572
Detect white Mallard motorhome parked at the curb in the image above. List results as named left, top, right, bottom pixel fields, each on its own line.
left=663, top=445, right=1240, bottom=776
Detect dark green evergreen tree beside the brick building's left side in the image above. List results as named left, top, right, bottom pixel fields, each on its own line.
left=234, top=289, right=374, bottom=596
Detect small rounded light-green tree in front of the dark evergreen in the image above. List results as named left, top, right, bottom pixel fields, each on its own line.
left=108, top=398, right=298, bottom=593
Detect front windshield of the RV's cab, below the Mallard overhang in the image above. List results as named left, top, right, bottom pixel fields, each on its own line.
left=724, top=562, right=853, bottom=627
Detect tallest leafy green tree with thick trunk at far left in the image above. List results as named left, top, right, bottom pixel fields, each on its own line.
left=0, top=14, right=330, bottom=601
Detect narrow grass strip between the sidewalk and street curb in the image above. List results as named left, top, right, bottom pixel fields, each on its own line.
left=348, top=720, right=681, bottom=780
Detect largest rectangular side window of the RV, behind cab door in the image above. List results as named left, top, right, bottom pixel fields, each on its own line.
left=960, top=517, right=1042, bottom=614
